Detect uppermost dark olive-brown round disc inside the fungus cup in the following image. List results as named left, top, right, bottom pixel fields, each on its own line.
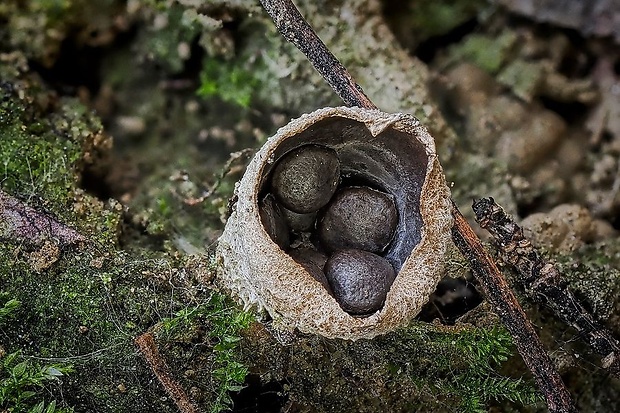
left=271, top=145, right=340, bottom=214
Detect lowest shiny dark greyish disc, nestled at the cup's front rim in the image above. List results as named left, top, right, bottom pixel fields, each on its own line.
left=325, top=249, right=396, bottom=316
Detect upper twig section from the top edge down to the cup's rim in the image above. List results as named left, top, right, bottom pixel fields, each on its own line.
left=261, top=0, right=377, bottom=109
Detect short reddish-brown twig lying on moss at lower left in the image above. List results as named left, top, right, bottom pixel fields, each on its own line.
left=135, top=332, right=199, bottom=413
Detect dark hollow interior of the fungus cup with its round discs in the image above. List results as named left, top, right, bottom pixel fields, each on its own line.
left=258, top=116, right=430, bottom=317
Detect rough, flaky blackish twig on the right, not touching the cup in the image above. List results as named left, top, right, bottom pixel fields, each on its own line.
left=473, top=198, right=620, bottom=377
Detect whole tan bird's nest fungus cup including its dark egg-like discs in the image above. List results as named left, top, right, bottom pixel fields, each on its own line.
left=216, top=107, right=453, bottom=340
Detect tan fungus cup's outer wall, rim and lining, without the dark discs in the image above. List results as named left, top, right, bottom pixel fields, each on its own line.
left=217, top=107, right=452, bottom=340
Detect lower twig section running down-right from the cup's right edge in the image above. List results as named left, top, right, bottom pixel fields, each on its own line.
left=452, top=205, right=577, bottom=413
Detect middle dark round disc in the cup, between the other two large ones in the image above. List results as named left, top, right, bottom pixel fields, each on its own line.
left=319, top=186, right=398, bottom=253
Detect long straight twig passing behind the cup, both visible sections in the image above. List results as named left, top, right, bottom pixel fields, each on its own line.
left=261, top=0, right=576, bottom=413
